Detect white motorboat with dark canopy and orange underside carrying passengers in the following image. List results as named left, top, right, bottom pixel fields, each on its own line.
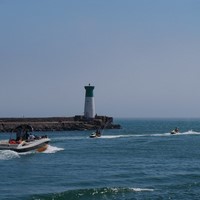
left=0, top=125, right=50, bottom=152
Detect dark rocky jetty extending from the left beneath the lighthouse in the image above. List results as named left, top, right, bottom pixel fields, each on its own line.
left=0, top=116, right=121, bottom=132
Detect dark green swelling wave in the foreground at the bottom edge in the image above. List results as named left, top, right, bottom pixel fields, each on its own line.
left=32, top=187, right=154, bottom=200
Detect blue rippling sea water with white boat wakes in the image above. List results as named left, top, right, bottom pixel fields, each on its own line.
left=0, top=119, right=200, bottom=200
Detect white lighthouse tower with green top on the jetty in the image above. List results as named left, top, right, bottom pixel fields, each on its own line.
left=84, top=84, right=95, bottom=119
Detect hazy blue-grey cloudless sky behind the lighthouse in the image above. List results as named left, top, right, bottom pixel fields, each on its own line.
left=0, top=0, right=200, bottom=118
